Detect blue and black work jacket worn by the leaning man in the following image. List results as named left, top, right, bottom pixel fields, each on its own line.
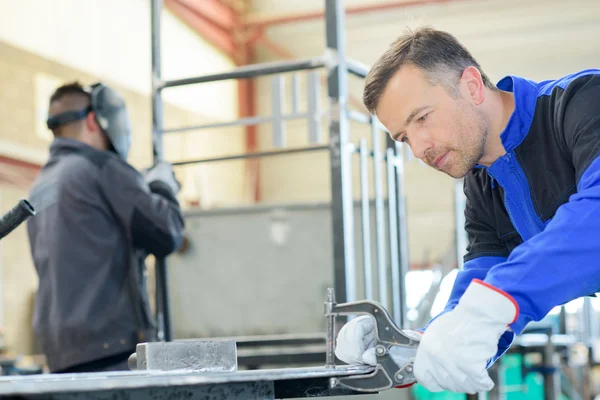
left=428, top=70, right=600, bottom=365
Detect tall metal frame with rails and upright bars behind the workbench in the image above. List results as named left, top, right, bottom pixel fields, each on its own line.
left=151, top=0, right=408, bottom=341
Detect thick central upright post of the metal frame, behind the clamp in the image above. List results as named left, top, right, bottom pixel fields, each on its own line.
left=325, top=0, right=356, bottom=303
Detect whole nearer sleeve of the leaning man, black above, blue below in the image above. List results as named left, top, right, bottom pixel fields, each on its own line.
left=484, top=76, right=600, bottom=334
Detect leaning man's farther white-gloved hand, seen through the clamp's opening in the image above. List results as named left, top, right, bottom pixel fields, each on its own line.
left=335, top=315, right=421, bottom=366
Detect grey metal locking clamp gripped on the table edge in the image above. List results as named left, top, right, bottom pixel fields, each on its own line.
left=325, top=289, right=419, bottom=392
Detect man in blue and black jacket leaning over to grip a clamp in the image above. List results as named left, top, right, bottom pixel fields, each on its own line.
left=336, top=28, right=600, bottom=394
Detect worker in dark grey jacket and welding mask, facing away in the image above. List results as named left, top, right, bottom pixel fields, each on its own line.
left=27, top=82, right=184, bottom=372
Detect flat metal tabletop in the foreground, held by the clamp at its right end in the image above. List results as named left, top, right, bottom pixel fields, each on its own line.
left=0, top=365, right=373, bottom=399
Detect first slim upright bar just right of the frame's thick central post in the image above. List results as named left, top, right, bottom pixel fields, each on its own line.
left=360, top=138, right=375, bottom=300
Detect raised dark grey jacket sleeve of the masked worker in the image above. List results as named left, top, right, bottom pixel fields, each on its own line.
left=99, top=158, right=185, bottom=257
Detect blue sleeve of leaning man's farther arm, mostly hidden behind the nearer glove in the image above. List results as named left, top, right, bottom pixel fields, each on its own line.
left=417, top=257, right=514, bottom=367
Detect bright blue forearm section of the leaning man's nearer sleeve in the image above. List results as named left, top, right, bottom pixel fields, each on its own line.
left=484, top=158, right=600, bottom=334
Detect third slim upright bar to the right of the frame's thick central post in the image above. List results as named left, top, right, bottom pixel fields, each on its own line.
left=385, top=147, right=402, bottom=324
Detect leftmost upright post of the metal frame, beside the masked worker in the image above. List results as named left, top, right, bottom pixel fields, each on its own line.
left=150, top=0, right=172, bottom=342
